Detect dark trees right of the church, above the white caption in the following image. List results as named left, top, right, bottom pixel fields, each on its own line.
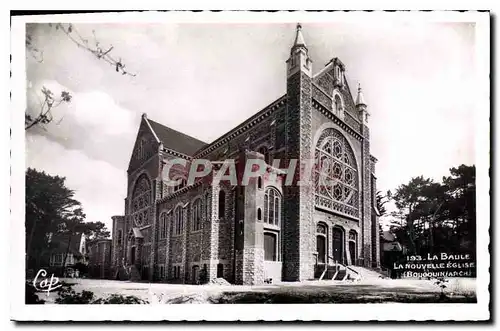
left=390, top=165, right=476, bottom=255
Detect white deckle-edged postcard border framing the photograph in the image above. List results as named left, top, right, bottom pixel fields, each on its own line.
left=8, top=12, right=490, bottom=321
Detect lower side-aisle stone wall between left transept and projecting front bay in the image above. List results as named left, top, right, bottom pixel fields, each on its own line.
left=158, top=178, right=238, bottom=283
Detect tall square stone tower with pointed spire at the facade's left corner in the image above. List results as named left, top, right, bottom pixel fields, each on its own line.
left=283, top=24, right=315, bottom=281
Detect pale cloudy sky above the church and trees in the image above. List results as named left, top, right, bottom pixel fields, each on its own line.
left=26, top=20, right=478, bottom=228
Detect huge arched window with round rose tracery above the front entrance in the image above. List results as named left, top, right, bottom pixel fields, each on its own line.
left=314, top=128, right=359, bottom=217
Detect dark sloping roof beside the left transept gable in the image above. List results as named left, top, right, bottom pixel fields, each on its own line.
left=148, top=118, right=207, bottom=155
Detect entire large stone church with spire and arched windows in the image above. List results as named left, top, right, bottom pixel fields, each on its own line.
left=112, top=25, right=380, bottom=284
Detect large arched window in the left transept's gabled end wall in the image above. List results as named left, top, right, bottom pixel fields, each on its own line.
left=131, top=175, right=152, bottom=227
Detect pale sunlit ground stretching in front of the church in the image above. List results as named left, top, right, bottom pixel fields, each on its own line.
left=44, top=277, right=476, bottom=304
